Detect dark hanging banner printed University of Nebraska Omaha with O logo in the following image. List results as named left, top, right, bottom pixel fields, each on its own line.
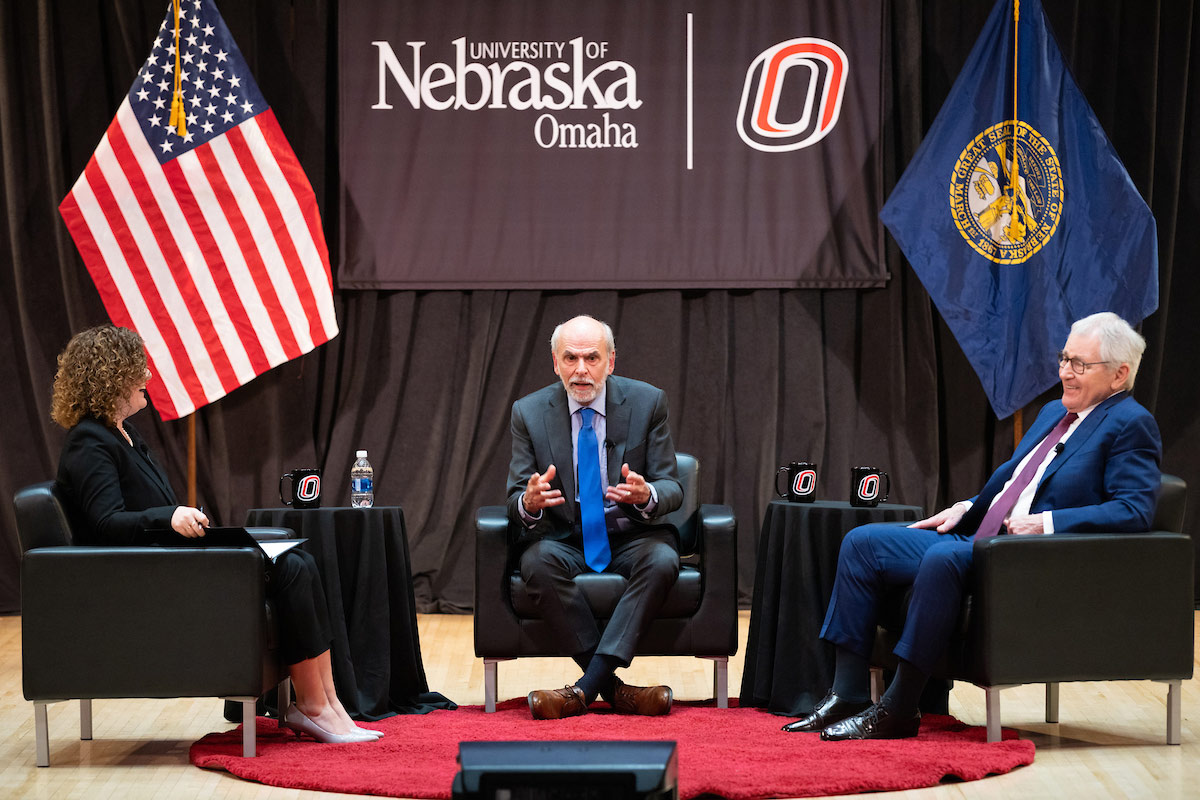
left=337, top=0, right=887, bottom=289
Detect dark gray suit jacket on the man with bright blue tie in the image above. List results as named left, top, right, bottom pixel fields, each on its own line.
left=508, top=375, right=683, bottom=539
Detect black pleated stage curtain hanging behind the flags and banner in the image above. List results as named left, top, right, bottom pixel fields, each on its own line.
left=0, top=0, right=1200, bottom=612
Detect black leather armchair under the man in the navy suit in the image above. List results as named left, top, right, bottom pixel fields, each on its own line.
left=872, top=475, right=1194, bottom=745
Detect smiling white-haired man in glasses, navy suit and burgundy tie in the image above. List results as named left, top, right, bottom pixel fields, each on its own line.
left=784, top=312, right=1162, bottom=740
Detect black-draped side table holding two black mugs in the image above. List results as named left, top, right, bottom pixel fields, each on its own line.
left=739, top=500, right=922, bottom=716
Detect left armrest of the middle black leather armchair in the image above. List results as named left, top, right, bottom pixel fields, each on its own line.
left=475, top=506, right=520, bottom=656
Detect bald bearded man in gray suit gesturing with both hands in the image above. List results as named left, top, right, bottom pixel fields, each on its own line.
left=508, top=317, right=683, bottom=720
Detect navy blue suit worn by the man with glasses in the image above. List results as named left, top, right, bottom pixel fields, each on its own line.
left=821, top=392, right=1162, bottom=674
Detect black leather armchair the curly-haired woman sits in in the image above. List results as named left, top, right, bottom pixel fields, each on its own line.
left=13, top=482, right=290, bottom=766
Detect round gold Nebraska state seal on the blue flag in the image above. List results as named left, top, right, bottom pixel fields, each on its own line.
left=950, top=120, right=1063, bottom=264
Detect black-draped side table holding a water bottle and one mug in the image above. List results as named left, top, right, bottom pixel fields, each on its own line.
left=246, top=506, right=456, bottom=721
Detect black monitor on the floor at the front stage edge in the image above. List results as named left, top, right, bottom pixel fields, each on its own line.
left=451, top=741, right=679, bottom=800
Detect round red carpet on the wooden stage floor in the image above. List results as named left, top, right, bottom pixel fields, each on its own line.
left=191, top=699, right=1033, bottom=800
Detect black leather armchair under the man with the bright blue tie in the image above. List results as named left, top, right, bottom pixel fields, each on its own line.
left=475, top=453, right=738, bottom=711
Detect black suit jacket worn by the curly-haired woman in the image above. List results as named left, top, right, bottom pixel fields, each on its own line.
left=58, top=417, right=180, bottom=545
